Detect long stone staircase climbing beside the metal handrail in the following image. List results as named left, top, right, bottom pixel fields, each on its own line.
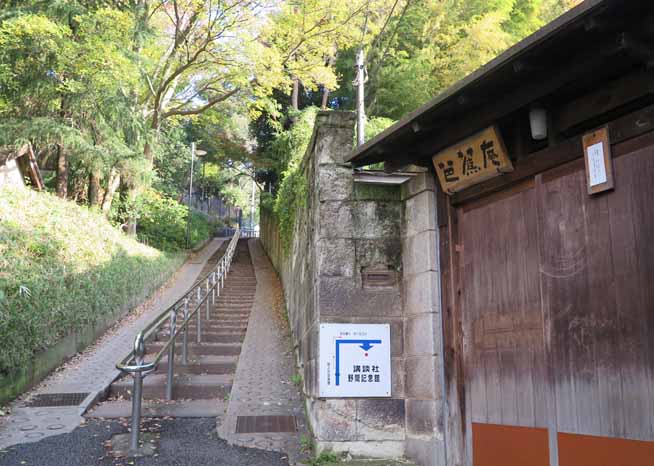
left=87, top=239, right=256, bottom=418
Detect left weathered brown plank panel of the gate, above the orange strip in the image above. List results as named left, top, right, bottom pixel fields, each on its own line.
left=461, top=188, right=547, bottom=427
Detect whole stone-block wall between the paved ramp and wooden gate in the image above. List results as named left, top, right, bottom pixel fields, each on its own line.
left=261, top=112, right=443, bottom=465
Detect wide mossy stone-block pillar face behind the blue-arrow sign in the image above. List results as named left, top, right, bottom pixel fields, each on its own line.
left=308, top=112, right=405, bottom=457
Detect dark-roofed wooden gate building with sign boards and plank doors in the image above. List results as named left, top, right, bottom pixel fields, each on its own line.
left=349, top=0, right=654, bottom=466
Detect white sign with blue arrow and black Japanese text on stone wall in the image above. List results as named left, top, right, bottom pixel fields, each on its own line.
left=319, top=324, right=391, bottom=398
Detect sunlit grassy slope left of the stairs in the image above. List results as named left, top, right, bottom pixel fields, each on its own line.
left=0, top=187, right=181, bottom=376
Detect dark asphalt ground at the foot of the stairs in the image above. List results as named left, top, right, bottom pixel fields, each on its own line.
left=0, top=418, right=288, bottom=466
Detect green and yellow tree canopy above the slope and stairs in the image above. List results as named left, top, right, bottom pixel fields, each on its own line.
left=0, top=0, right=578, bottom=240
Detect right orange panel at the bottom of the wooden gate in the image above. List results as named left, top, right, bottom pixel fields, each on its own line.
left=558, top=433, right=654, bottom=466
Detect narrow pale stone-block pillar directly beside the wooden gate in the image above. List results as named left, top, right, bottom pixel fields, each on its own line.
left=402, top=172, right=445, bottom=466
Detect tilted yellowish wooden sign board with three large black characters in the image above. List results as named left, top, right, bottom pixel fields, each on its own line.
left=432, top=126, right=513, bottom=194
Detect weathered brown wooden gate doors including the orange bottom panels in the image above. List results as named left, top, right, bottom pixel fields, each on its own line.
left=457, top=138, right=654, bottom=466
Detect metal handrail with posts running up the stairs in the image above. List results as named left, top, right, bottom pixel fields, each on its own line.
left=116, top=228, right=240, bottom=452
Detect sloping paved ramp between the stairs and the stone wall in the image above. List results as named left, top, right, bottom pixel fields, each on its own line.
left=218, top=239, right=308, bottom=464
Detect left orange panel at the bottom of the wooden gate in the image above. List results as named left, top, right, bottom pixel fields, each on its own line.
left=472, top=423, right=550, bottom=466
